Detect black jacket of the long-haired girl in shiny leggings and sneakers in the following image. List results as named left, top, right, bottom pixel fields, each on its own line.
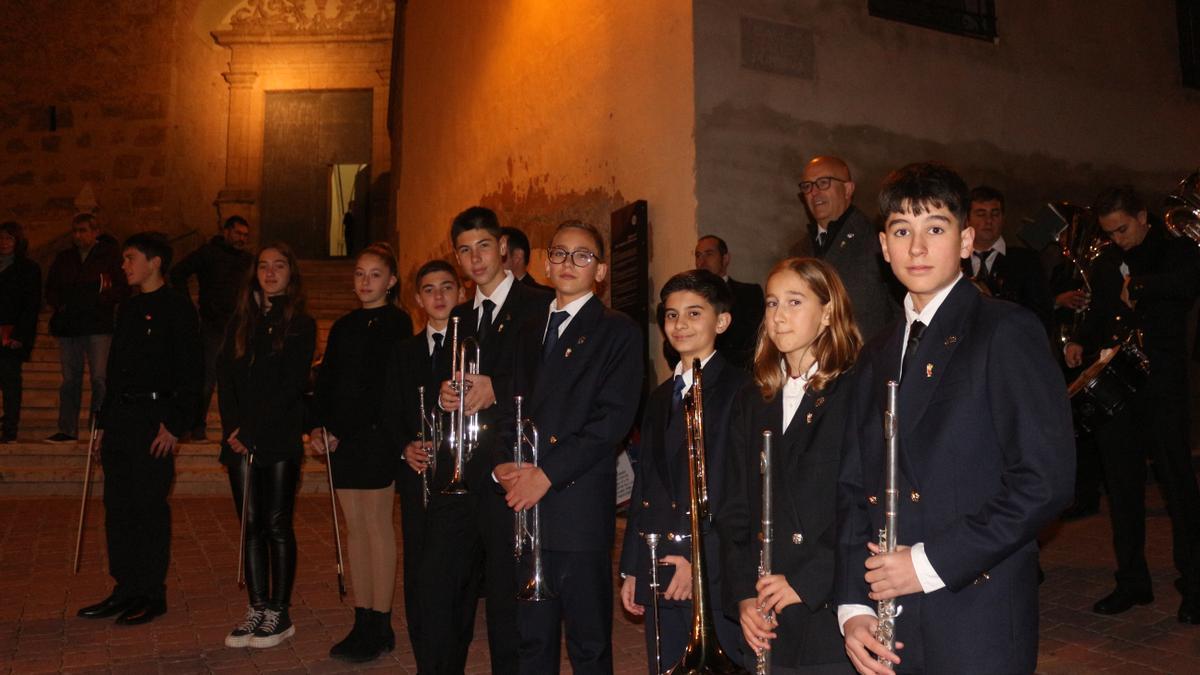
left=217, top=304, right=317, bottom=465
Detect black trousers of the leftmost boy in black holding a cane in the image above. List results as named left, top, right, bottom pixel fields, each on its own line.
left=101, top=413, right=175, bottom=598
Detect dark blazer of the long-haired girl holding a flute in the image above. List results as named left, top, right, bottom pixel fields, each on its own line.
left=716, top=374, right=851, bottom=668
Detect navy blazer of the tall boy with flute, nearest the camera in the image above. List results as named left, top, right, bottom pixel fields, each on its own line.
left=835, top=277, right=1075, bottom=673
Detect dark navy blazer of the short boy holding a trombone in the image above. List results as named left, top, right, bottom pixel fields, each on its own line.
left=620, top=352, right=750, bottom=607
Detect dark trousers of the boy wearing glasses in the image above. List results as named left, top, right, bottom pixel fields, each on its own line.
left=517, top=550, right=612, bottom=675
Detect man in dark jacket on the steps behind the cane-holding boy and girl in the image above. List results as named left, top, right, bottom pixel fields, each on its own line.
left=170, top=216, right=254, bottom=441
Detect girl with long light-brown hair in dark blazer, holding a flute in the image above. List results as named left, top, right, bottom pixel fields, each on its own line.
left=716, top=258, right=862, bottom=675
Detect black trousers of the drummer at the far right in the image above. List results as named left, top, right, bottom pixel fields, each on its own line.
left=1096, top=354, right=1200, bottom=593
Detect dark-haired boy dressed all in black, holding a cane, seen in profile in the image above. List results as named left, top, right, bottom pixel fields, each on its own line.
left=79, top=232, right=203, bottom=626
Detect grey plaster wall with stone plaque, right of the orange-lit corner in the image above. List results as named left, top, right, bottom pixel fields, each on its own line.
left=694, top=0, right=1200, bottom=280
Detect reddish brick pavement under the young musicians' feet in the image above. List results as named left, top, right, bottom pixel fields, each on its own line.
left=0, top=491, right=1200, bottom=675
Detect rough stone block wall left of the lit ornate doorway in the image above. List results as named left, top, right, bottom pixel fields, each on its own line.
left=0, top=0, right=228, bottom=258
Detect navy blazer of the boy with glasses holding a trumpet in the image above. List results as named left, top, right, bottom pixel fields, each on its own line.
left=493, top=297, right=643, bottom=551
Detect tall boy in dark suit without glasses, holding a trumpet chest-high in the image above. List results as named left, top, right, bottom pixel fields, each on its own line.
left=419, top=207, right=550, bottom=673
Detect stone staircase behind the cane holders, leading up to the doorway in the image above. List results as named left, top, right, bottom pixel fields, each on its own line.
left=0, top=259, right=358, bottom=496
